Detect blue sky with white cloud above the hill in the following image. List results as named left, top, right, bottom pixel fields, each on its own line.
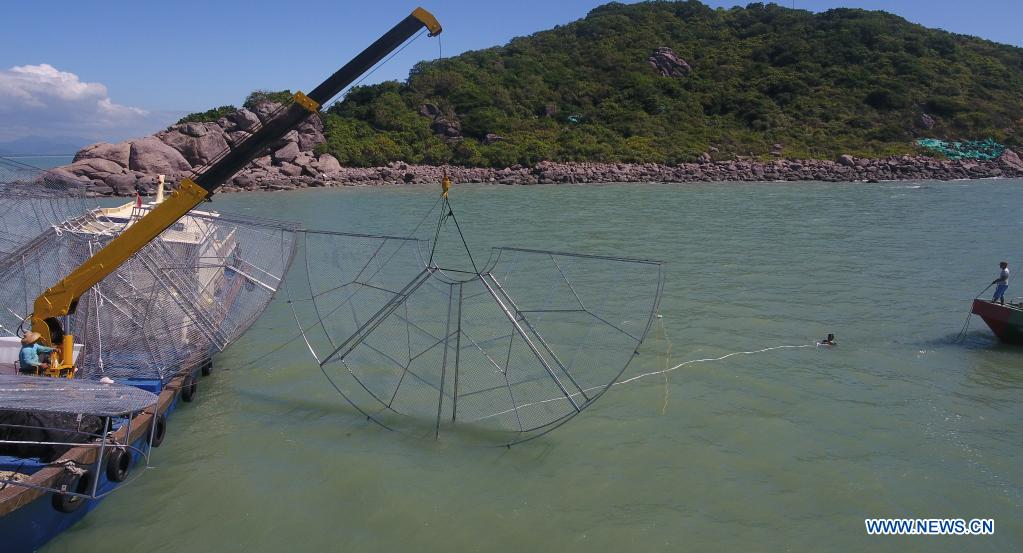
left=0, top=0, right=1023, bottom=145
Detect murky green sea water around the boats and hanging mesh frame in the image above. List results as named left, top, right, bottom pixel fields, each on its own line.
left=44, top=180, right=1023, bottom=553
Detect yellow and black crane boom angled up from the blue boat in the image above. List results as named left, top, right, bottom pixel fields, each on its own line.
left=32, top=8, right=441, bottom=353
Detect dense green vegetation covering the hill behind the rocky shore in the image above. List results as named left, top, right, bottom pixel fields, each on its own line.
left=178, top=0, right=1023, bottom=167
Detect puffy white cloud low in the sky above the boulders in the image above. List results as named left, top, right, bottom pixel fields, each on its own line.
left=0, top=63, right=177, bottom=141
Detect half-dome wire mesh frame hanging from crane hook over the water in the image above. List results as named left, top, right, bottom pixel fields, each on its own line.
left=284, top=200, right=662, bottom=445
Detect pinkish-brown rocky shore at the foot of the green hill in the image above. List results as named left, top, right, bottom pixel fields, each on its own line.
left=52, top=103, right=1023, bottom=195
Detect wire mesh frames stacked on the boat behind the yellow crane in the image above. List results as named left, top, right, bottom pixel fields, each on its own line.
left=0, top=158, right=297, bottom=382
